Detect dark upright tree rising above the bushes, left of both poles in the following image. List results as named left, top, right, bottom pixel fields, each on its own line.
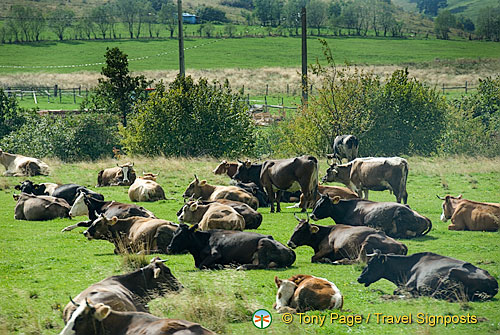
left=82, top=47, right=150, bottom=126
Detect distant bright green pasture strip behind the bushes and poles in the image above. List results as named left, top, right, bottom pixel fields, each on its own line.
left=0, top=37, right=500, bottom=73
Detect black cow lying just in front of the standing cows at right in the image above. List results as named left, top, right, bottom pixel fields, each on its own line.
left=311, top=195, right=432, bottom=238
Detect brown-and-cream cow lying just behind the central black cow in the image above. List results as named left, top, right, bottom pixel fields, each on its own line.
left=177, top=201, right=245, bottom=230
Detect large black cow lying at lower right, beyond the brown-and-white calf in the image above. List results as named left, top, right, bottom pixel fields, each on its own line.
left=358, top=250, right=498, bottom=301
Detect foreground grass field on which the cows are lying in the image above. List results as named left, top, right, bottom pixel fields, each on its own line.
left=0, top=157, right=500, bottom=334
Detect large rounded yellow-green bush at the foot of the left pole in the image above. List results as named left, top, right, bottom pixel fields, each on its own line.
left=120, top=76, right=255, bottom=157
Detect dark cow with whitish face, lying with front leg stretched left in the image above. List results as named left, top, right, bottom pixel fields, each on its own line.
left=62, top=192, right=156, bottom=232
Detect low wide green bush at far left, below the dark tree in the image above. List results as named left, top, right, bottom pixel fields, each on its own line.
left=0, top=113, right=118, bottom=161
